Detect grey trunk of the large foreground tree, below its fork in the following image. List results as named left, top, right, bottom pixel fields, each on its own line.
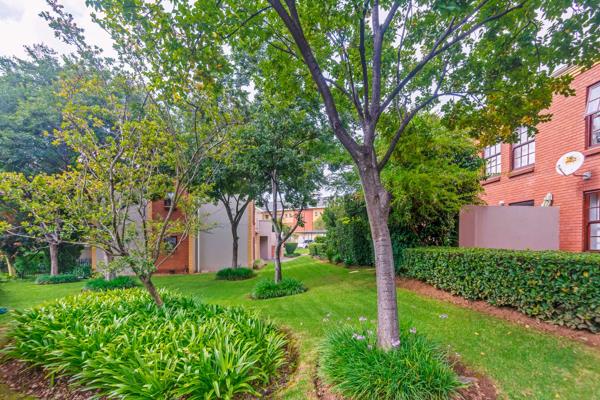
left=358, top=157, right=400, bottom=349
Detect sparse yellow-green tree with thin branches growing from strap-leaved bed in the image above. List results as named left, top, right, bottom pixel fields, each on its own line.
left=55, top=70, right=212, bottom=306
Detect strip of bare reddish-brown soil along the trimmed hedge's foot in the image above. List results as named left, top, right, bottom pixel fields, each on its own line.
left=396, top=278, right=600, bottom=348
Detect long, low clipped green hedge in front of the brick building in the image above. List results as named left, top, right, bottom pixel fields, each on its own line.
left=399, top=247, right=600, bottom=332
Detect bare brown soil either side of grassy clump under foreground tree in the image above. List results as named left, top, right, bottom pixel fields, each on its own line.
left=313, top=361, right=498, bottom=400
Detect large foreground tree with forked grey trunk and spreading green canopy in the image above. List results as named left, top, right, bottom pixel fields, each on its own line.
left=224, top=0, right=600, bottom=348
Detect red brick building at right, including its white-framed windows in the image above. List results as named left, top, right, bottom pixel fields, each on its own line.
left=482, top=64, right=600, bottom=251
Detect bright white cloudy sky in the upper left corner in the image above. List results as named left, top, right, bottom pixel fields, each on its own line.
left=0, top=0, right=115, bottom=57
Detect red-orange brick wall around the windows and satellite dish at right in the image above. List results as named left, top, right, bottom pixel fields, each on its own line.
left=482, top=64, right=600, bottom=251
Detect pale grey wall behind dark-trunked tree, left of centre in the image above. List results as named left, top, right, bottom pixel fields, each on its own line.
left=193, top=203, right=251, bottom=272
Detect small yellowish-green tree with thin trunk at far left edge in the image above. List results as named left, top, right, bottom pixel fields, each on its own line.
left=0, top=172, right=78, bottom=275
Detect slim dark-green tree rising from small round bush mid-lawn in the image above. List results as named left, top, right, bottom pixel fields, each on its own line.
left=244, top=100, right=325, bottom=283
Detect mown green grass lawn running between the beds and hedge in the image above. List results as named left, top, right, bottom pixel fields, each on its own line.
left=0, top=257, right=600, bottom=400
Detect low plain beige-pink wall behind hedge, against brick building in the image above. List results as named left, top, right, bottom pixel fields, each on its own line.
left=459, top=206, right=559, bottom=250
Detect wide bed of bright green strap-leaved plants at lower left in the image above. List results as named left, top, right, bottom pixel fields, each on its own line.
left=3, top=289, right=289, bottom=400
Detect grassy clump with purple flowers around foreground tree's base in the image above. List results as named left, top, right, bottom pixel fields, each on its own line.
left=319, top=324, right=463, bottom=400
